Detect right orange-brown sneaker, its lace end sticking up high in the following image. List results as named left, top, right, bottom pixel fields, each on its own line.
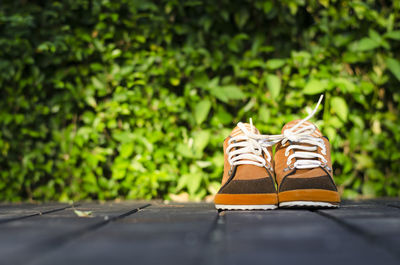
left=274, top=97, right=340, bottom=207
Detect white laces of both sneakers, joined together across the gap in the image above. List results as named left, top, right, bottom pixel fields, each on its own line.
left=226, top=95, right=328, bottom=169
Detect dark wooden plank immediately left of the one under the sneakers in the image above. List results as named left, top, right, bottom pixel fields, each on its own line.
left=29, top=204, right=217, bottom=265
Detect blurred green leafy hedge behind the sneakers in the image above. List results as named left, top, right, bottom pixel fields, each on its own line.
left=0, top=0, right=400, bottom=201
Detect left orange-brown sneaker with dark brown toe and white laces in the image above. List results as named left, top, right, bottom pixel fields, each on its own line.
left=214, top=122, right=278, bottom=210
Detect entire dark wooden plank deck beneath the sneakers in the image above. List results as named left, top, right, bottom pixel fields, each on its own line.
left=0, top=199, right=400, bottom=265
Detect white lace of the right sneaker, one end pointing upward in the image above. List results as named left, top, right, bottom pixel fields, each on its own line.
left=263, top=95, right=328, bottom=169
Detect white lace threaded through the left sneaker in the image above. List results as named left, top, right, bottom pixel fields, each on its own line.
left=226, top=119, right=271, bottom=169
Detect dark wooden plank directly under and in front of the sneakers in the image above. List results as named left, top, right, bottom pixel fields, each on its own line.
left=224, top=204, right=398, bottom=265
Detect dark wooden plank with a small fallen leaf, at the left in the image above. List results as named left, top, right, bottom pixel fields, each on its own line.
left=0, top=202, right=145, bottom=265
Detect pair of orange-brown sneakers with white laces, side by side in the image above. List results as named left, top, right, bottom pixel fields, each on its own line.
left=214, top=96, right=340, bottom=210
